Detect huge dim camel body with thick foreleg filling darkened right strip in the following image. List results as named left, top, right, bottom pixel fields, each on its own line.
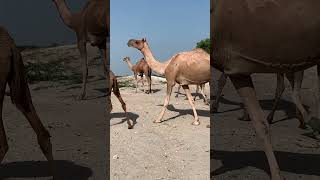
left=211, top=0, right=320, bottom=180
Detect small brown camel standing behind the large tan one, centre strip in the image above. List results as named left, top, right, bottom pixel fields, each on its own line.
left=123, top=57, right=152, bottom=94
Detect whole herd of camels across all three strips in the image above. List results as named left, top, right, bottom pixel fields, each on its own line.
left=0, top=0, right=320, bottom=180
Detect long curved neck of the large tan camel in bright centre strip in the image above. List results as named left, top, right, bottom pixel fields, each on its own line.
left=141, top=44, right=166, bottom=75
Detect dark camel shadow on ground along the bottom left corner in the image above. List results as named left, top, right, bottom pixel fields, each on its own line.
left=0, top=160, right=93, bottom=180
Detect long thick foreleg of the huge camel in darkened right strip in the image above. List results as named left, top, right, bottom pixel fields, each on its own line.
left=230, top=76, right=281, bottom=180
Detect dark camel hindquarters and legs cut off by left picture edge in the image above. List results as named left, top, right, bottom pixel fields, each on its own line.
left=0, top=26, right=55, bottom=179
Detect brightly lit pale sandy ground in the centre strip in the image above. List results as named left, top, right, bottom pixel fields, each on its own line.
left=110, top=77, right=210, bottom=180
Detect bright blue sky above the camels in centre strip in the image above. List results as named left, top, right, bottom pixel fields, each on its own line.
left=110, top=0, right=210, bottom=75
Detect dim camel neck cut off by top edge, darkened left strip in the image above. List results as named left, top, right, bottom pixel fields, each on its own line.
left=54, top=0, right=74, bottom=29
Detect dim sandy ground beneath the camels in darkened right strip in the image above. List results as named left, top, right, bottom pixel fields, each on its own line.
left=211, top=68, right=320, bottom=180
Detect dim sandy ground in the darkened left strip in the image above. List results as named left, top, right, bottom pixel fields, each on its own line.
left=0, top=45, right=107, bottom=180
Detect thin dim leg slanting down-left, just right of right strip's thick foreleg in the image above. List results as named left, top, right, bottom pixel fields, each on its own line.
left=267, top=73, right=285, bottom=123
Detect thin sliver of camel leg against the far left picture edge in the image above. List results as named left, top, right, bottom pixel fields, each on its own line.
left=0, top=80, right=9, bottom=163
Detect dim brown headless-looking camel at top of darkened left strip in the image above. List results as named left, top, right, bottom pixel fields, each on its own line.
left=53, top=0, right=110, bottom=100
